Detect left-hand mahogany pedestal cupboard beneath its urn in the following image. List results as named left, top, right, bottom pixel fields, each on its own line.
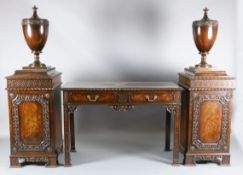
left=7, top=68, right=62, bottom=167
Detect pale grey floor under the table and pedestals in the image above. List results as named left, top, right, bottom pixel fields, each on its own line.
left=0, top=131, right=243, bottom=175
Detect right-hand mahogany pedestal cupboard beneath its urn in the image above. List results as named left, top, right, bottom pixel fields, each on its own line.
left=179, top=73, right=235, bottom=165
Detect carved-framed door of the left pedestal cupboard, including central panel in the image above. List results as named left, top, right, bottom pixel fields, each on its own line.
left=12, top=94, right=51, bottom=152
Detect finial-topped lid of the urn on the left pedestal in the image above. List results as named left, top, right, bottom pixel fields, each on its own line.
left=22, top=6, right=49, bottom=26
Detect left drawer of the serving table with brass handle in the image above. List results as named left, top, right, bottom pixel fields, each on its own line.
left=69, top=92, right=117, bottom=103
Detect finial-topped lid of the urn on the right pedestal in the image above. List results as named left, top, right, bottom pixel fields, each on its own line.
left=192, top=8, right=218, bottom=27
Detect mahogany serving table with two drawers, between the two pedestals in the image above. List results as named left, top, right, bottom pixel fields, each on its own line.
left=62, top=82, right=182, bottom=166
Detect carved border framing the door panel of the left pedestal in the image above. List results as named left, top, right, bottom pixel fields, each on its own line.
left=12, top=95, right=50, bottom=152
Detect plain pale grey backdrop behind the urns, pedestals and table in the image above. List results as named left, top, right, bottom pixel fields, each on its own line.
left=0, top=0, right=243, bottom=148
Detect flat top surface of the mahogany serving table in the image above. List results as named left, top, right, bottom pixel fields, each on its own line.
left=62, top=82, right=182, bottom=90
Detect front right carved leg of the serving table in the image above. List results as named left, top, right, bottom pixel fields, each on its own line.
left=171, top=105, right=181, bottom=165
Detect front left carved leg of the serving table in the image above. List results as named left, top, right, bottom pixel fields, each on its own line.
left=64, top=105, right=71, bottom=166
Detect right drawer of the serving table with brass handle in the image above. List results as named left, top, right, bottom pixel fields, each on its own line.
left=131, top=92, right=174, bottom=103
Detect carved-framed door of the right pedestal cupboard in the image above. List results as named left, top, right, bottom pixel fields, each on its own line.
left=191, top=91, right=232, bottom=152
